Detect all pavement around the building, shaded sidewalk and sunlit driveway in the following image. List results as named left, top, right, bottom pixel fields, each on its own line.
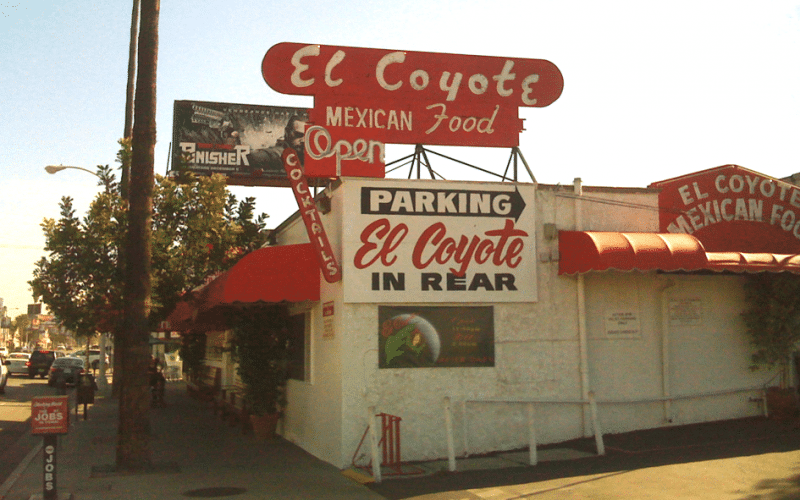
left=0, top=382, right=800, bottom=500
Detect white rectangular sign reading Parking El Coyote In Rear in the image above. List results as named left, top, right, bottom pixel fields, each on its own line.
left=342, top=179, right=537, bottom=303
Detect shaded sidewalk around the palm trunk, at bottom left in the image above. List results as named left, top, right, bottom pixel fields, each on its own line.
left=2, top=382, right=383, bottom=500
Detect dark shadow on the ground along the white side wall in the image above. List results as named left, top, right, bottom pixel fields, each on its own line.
left=368, top=417, right=800, bottom=500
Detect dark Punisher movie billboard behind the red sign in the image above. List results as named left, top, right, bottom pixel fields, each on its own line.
left=172, top=101, right=309, bottom=186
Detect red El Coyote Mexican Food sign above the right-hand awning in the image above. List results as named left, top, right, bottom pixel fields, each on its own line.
left=650, top=165, right=800, bottom=255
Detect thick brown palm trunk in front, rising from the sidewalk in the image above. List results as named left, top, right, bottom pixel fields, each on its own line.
left=116, top=0, right=159, bottom=471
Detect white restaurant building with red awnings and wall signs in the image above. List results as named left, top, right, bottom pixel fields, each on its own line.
left=180, top=166, right=788, bottom=468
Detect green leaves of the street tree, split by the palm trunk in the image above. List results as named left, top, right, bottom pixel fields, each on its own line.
left=29, top=140, right=267, bottom=334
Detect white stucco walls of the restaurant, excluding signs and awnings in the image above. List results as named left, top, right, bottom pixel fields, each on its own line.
left=278, top=180, right=769, bottom=468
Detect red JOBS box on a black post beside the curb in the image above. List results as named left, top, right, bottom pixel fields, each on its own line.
left=31, top=396, right=69, bottom=500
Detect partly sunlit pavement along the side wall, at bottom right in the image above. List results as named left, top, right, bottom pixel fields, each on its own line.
left=370, top=417, right=800, bottom=500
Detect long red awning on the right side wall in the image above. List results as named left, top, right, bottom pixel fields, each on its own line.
left=558, top=231, right=800, bottom=274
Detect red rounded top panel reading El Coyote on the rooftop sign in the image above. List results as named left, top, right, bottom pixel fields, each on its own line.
left=261, top=42, right=564, bottom=107
